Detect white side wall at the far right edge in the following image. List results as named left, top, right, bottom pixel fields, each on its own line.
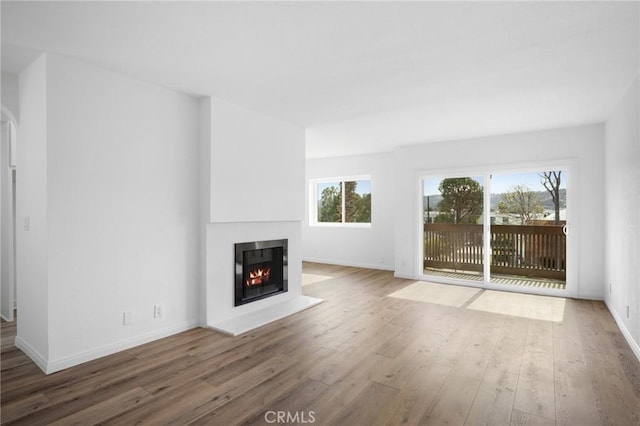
left=604, top=78, right=640, bottom=359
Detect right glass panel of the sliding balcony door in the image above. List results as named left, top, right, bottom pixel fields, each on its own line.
left=490, top=170, right=567, bottom=289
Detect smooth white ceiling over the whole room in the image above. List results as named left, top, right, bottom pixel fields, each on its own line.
left=1, top=1, right=640, bottom=157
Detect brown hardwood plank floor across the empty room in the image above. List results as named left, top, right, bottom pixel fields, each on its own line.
left=1, top=264, right=640, bottom=425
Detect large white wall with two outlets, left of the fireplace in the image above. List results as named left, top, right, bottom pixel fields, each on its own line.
left=18, top=55, right=202, bottom=372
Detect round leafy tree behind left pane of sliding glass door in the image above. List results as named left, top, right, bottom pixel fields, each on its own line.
left=436, top=177, right=483, bottom=224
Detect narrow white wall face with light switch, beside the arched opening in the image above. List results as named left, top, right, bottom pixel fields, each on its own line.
left=16, top=56, right=50, bottom=368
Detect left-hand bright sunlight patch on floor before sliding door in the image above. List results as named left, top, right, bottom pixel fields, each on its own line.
left=389, top=281, right=480, bottom=308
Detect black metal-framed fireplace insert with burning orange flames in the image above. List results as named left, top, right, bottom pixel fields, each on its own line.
left=235, top=239, right=288, bottom=306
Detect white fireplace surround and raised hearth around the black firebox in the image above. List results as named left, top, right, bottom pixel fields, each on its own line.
left=205, top=221, right=322, bottom=336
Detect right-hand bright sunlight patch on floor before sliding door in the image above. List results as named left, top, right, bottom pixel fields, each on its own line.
left=468, top=290, right=566, bottom=322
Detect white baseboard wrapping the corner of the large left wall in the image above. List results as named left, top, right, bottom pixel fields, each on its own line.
left=15, top=319, right=202, bottom=374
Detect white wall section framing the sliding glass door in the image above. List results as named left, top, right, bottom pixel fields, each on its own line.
left=395, top=125, right=604, bottom=299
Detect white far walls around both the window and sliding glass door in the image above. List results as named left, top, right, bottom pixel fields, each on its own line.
left=303, top=124, right=604, bottom=299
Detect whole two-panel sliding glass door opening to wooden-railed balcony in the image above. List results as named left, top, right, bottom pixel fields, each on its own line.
left=422, top=169, right=567, bottom=291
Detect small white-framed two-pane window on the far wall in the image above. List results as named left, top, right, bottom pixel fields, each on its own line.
left=310, top=176, right=371, bottom=225
